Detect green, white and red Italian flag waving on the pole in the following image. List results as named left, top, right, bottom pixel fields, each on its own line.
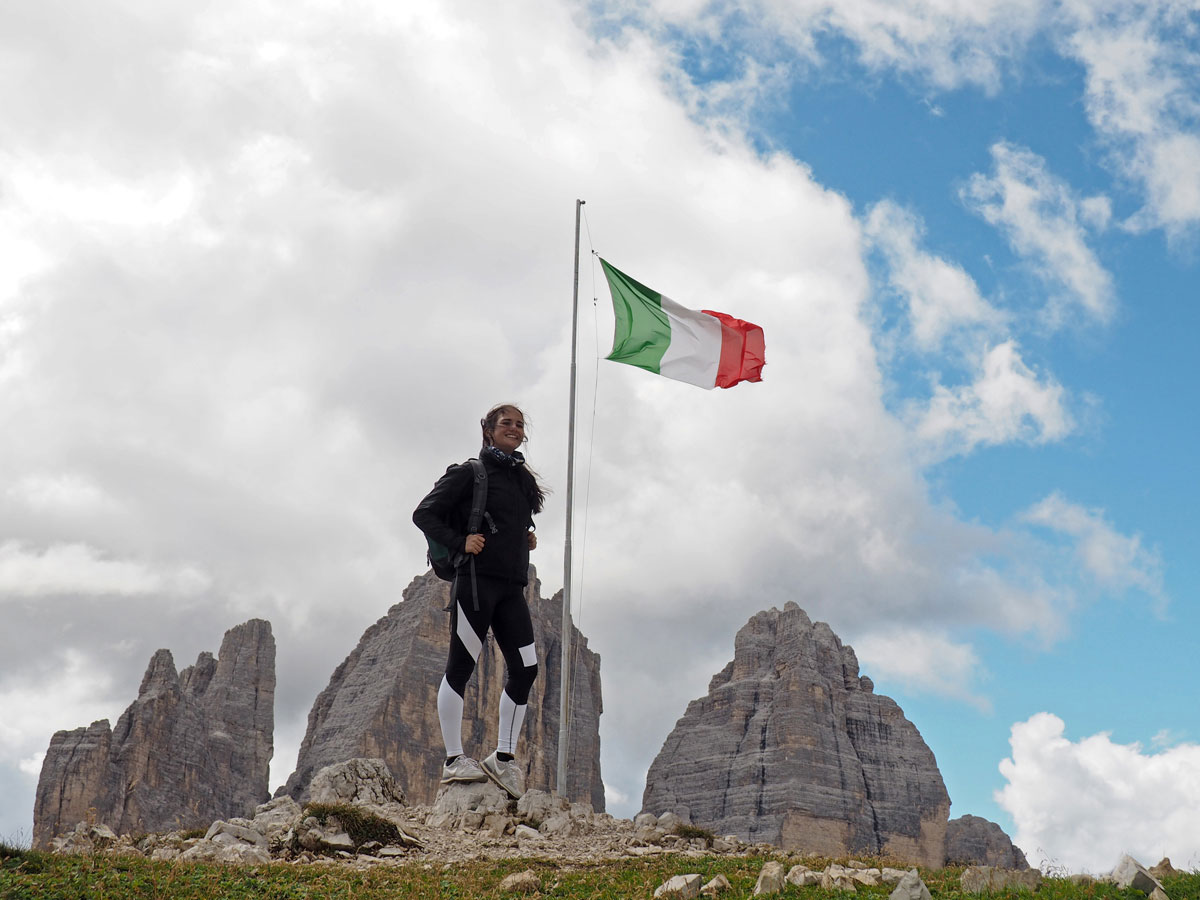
left=600, top=259, right=767, bottom=389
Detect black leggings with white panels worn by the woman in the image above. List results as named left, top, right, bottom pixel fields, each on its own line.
left=446, top=572, right=538, bottom=706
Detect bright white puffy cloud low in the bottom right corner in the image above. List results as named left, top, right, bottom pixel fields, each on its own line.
left=996, top=713, right=1200, bottom=874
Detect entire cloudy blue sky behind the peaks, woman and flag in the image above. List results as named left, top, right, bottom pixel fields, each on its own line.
left=0, top=0, right=1200, bottom=872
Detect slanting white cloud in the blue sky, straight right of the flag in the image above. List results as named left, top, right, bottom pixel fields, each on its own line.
left=865, top=200, right=1003, bottom=350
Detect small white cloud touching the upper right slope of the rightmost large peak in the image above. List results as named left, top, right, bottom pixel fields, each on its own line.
left=854, top=629, right=991, bottom=713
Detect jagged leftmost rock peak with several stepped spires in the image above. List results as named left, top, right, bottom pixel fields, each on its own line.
left=34, top=619, right=275, bottom=847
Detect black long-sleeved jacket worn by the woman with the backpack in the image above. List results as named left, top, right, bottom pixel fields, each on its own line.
left=413, top=454, right=533, bottom=584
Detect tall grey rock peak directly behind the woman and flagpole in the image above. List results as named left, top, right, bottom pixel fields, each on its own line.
left=276, top=569, right=604, bottom=810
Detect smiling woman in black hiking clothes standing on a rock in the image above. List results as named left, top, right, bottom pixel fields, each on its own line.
left=413, top=403, right=546, bottom=798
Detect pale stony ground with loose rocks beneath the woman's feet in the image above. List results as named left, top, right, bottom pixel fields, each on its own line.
left=37, top=760, right=1175, bottom=900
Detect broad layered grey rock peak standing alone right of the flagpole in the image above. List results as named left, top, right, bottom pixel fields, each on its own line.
left=642, top=602, right=950, bottom=868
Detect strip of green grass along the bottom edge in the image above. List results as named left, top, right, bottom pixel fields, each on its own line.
left=0, top=847, right=1200, bottom=900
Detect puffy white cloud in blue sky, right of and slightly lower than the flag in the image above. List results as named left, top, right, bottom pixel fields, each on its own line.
left=914, top=341, right=1074, bottom=457
